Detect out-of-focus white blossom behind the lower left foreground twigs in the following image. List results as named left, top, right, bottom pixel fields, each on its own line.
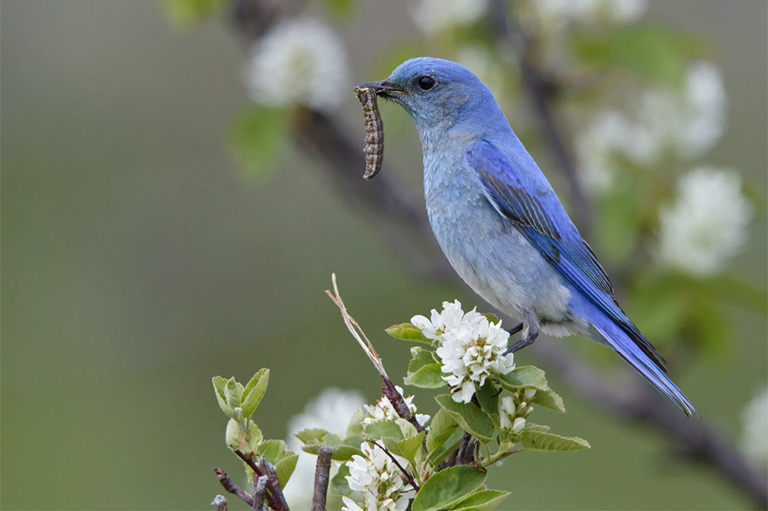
left=284, top=388, right=365, bottom=509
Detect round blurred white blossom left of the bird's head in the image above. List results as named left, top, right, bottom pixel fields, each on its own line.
left=245, top=18, right=349, bottom=110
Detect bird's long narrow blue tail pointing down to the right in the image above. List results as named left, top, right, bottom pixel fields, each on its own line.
left=590, top=310, right=699, bottom=417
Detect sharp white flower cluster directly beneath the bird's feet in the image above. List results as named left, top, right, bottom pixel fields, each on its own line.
left=411, top=300, right=515, bottom=403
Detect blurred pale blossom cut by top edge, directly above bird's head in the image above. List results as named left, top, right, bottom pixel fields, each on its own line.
left=409, top=0, right=489, bottom=34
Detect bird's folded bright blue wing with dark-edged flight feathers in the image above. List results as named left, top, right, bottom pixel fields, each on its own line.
left=467, top=140, right=666, bottom=370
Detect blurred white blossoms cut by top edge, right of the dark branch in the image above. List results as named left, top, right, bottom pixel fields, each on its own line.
left=531, top=0, right=648, bottom=25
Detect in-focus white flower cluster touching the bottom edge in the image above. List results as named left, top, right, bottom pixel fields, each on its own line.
left=342, top=442, right=416, bottom=511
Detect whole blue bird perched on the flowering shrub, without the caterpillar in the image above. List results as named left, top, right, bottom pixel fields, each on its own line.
left=358, top=57, right=698, bottom=416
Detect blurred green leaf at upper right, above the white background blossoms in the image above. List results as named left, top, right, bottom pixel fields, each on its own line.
left=572, top=25, right=703, bottom=85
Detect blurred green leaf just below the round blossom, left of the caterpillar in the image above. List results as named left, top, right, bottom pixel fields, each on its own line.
left=229, top=107, right=289, bottom=181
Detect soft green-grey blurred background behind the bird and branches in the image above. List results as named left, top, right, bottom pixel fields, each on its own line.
left=0, top=0, right=768, bottom=509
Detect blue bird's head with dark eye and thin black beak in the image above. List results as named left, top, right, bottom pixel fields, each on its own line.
left=360, top=57, right=498, bottom=135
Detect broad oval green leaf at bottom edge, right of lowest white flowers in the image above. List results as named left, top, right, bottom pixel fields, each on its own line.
left=411, top=466, right=485, bottom=511
